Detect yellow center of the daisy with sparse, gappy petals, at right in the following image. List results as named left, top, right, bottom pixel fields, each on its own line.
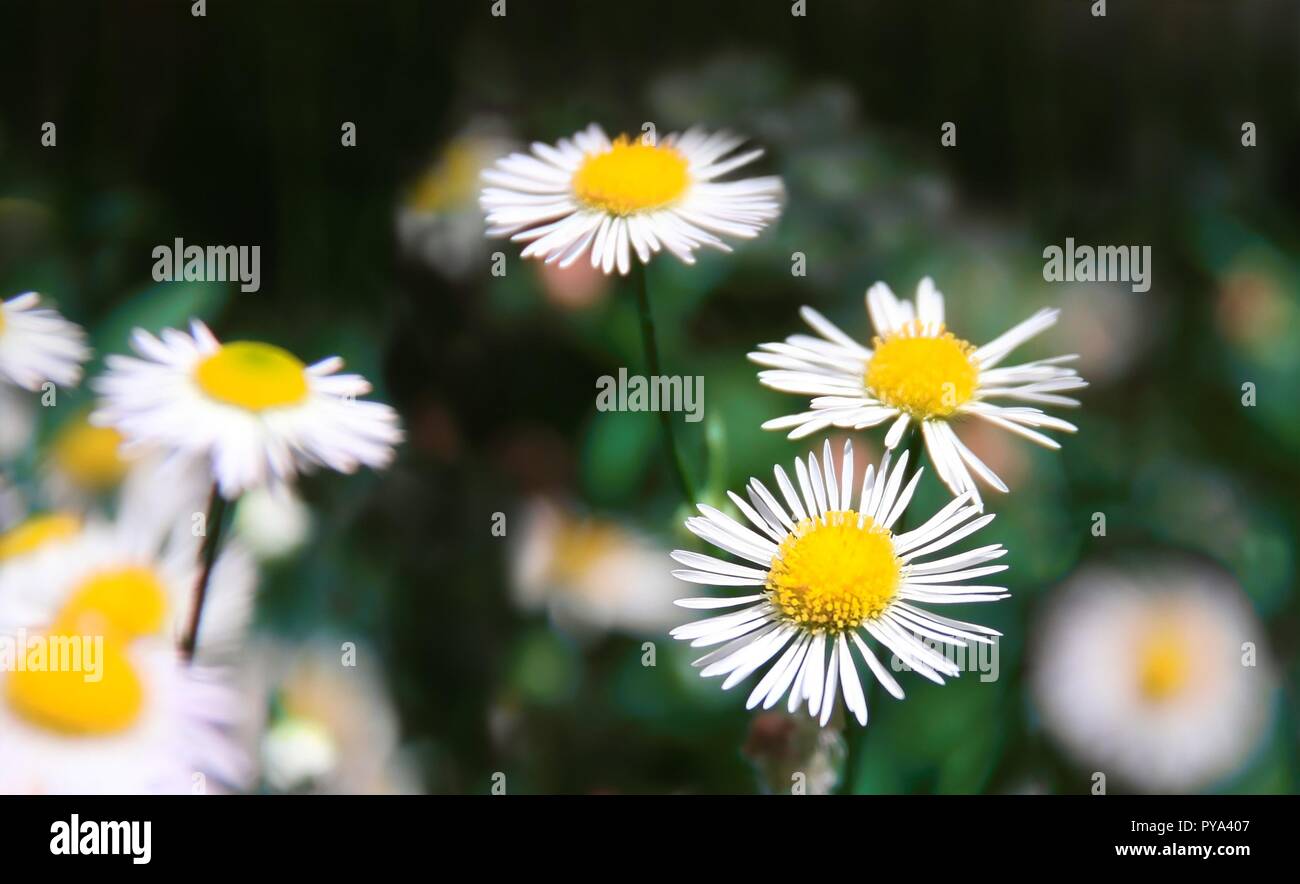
left=863, top=322, right=979, bottom=419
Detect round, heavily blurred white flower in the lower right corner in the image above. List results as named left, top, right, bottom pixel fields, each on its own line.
left=1034, top=560, right=1274, bottom=792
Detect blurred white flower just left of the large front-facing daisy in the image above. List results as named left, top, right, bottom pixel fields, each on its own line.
left=511, top=498, right=677, bottom=636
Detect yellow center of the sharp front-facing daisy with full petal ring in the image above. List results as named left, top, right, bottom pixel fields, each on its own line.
left=767, top=510, right=902, bottom=632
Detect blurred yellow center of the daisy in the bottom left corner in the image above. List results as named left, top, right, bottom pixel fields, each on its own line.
left=7, top=631, right=144, bottom=736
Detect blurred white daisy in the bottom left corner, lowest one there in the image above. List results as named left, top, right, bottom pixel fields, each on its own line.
left=0, top=628, right=248, bottom=794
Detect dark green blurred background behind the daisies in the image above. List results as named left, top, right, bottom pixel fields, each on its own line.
left=0, top=0, right=1300, bottom=793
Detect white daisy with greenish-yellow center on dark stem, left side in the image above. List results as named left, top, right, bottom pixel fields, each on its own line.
left=91, top=320, right=402, bottom=498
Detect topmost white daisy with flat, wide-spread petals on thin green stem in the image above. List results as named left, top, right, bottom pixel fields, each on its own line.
left=480, top=124, right=783, bottom=274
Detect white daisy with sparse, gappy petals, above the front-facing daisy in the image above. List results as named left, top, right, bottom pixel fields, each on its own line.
left=749, top=277, right=1087, bottom=504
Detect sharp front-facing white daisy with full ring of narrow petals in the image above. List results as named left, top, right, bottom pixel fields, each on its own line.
left=671, top=442, right=1008, bottom=725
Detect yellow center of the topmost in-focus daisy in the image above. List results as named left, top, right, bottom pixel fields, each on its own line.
left=573, top=135, right=690, bottom=215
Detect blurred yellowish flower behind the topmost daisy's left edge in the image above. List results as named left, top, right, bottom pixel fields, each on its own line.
left=397, top=121, right=511, bottom=278
